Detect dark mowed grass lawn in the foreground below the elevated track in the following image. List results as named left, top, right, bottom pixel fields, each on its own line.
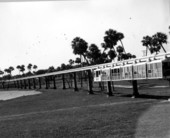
left=0, top=79, right=170, bottom=138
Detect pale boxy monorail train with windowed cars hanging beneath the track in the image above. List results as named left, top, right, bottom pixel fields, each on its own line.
left=94, top=58, right=170, bottom=82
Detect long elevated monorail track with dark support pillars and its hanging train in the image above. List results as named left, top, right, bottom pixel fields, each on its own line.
left=0, top=52, right=170, bottom=96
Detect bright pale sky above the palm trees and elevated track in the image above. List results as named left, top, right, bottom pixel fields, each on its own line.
left=0, top=0, right=170, bottom=73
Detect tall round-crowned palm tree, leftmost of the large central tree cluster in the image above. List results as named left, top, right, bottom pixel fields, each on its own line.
left=71, top=37, right=89, bottom=64
